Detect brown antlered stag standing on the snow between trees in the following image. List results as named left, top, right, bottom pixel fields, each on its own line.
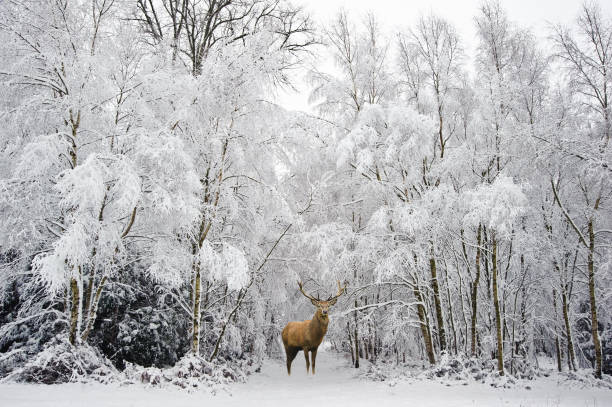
left=282, top=281, right=346, bottom=376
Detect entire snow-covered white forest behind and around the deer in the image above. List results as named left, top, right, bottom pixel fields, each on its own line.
left=0, top=0, right=612, bottom=404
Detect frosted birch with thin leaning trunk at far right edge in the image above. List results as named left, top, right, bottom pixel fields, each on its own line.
left=551, top=3, right=612, bottom=378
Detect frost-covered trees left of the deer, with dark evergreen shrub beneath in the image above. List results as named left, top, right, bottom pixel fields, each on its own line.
left=0, top=0, right=314, bottom=374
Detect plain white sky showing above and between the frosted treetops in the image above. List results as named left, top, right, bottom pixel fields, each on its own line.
left=277, top=0, right=612, bottom=110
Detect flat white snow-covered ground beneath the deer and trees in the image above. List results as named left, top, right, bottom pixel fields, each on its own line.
left=0, top=351, right=612, bottom=407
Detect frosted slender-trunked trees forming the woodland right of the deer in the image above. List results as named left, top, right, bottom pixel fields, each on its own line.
left=312, top=2, right=612, bottom=377
